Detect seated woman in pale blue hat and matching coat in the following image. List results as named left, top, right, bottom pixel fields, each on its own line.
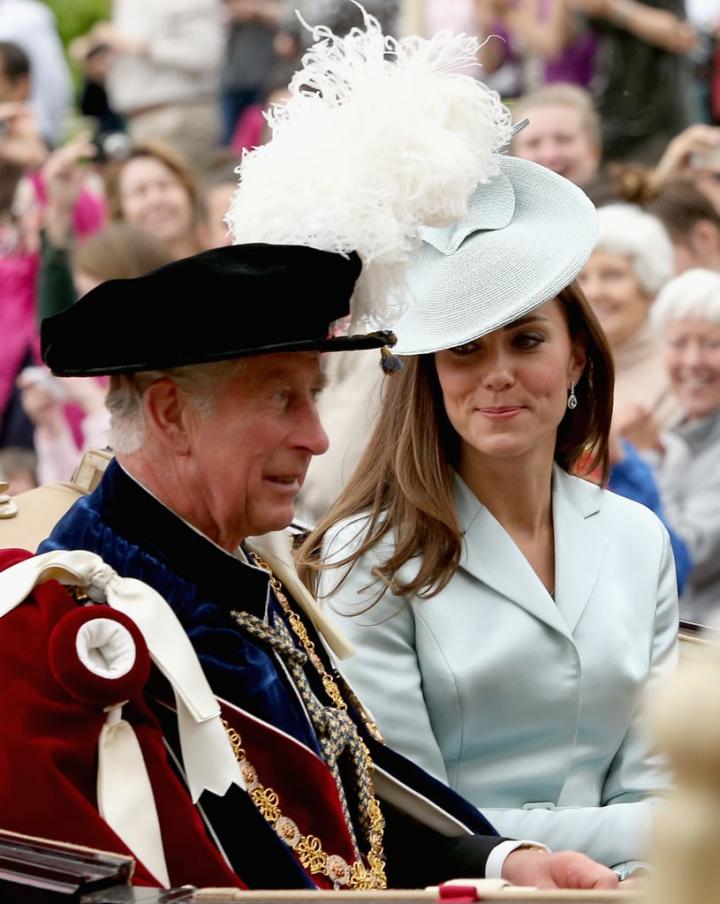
left=300, top=158, right=677, bottom=875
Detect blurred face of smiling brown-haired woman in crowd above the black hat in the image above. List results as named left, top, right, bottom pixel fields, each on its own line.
left=119, top=157, right=194, bottom=242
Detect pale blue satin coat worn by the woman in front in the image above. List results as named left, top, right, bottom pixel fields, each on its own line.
left=321, top=467, right=678, bottom=866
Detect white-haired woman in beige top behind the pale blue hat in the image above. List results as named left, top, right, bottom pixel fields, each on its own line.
left=578, top=204, right=681, bottom=448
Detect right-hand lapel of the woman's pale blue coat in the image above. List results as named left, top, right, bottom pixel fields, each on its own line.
left=553, top=467, right=608, bottom=632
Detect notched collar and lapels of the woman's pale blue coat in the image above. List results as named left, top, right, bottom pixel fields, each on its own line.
left=455, top=465, right=607, bottom=637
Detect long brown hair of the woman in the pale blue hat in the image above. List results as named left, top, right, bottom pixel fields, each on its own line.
left=297, top=283, right=614, bottom=598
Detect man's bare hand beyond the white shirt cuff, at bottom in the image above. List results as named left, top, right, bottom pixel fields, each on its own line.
left=502, top=848, right=619, bottom=889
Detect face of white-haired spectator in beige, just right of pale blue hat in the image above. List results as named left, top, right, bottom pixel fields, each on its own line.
left=578, top=249, right=652, bottom=348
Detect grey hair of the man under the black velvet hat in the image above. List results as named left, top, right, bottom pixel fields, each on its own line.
left=105, top=358, right=247, bottom=454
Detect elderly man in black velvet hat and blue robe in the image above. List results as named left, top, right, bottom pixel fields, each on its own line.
left=0, top=244, right=616, bottom=888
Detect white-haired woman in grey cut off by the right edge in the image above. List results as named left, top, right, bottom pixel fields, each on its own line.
left=653, top=269, right=720, bottom=623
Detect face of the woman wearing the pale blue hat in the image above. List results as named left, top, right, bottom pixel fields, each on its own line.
left=435, top=299, right=585, bottom=470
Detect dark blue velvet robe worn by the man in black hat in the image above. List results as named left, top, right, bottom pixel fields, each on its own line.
left=38, top=461, right=502, bottom=888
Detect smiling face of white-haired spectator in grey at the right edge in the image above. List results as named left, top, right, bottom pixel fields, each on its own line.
left=663, top=319, right=720, bottom=420
